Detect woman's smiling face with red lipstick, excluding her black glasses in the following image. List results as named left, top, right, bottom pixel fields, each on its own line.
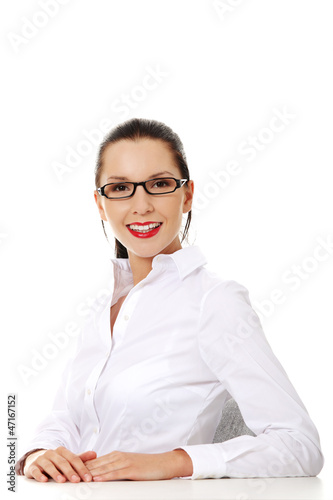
left=94, top=139, right=193, bottom=257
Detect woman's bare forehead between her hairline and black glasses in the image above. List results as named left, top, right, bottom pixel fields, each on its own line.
left=103, top=139, right=179, bottom=180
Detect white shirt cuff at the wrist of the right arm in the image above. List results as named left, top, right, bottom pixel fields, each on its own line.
left=177, top=444, right=226, bottom=479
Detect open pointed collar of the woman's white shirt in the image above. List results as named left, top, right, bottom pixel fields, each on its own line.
left=111, top=245, right=207, bottom=286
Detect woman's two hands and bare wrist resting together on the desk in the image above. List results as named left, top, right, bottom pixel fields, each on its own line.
left=25, top=446, right=193, bottom=483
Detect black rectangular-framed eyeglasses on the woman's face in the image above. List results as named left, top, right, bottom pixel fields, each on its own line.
left=97, top=177, right=187, bottom=200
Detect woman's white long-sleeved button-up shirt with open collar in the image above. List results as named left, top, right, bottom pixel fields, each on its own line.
left=18, top=246, right=323, bottom=479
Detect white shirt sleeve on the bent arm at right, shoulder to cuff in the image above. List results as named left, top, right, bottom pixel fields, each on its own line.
left=175, top=281, right=323, bottom=479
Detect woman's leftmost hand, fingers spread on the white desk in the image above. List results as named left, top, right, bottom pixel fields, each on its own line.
left=25, top=446, right=97, bottom=483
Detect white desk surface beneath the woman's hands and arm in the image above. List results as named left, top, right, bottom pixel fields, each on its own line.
left=14, top=477, right=333, bottom=500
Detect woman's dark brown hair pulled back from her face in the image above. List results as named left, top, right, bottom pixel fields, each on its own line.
left=95, top=118, right=192, bottom=258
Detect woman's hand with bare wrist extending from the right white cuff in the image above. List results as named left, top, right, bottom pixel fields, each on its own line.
left=85, top=449, right=193, bottom=481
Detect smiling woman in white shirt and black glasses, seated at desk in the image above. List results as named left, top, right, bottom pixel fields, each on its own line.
left=17, top=119, right=323, bottom=482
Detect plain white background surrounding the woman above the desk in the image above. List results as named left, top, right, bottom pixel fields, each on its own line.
left=0, top=0, right=333, bottom=490
